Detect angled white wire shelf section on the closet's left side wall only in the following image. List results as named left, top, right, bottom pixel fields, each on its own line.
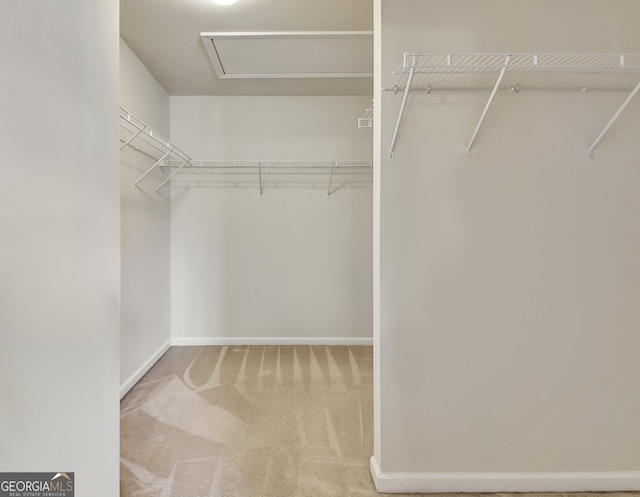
left=120, top=107, right=191, bottom=191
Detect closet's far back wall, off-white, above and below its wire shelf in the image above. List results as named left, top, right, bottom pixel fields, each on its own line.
left=170, top=97, right=372, bottom=343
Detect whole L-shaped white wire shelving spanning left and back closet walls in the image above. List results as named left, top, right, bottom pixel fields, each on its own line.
left=120, top=107, right=373, bottom=198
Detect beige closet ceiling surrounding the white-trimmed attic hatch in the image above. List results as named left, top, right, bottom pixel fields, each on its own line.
left=120, top=0, right=373, bottom=95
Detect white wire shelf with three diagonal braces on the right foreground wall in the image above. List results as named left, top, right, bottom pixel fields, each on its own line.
left=383, top=52, right=640, bottom=161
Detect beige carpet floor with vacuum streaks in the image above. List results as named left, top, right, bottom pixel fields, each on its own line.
left=120, top=346, right=638, bottom=497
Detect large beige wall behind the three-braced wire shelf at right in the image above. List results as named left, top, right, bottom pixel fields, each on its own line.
left=374, top=0, right=640, bottom=491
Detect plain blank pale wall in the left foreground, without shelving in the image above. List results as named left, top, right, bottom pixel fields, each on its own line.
left=0, top=0, right=120, bottom=497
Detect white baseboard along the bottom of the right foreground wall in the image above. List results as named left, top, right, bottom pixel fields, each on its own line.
left=370, top=457, right=640, bottom=493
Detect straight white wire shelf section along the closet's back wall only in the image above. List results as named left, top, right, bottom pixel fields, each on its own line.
left=162, top=160, right=373, bottom=196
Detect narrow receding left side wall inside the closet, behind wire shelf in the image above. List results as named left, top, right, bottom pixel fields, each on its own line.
left=120, top=40, right=171, bottom=395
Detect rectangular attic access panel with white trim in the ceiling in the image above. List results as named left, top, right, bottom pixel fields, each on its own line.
left=200, top=31, right=373, bottom=79
